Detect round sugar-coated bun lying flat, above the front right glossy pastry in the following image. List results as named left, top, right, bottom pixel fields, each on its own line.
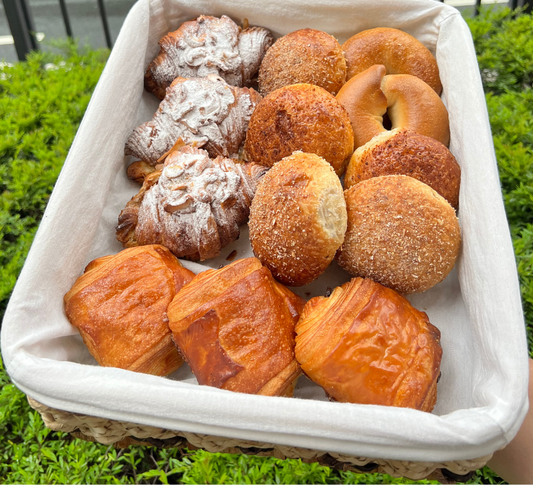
left=337, top=175, right=461, bottom=293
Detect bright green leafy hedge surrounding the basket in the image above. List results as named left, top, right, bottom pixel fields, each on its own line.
left=0, top=9, right=533, bottom=484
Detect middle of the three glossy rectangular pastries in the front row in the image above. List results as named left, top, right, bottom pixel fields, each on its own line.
left=168, top=258, right=305, bottom=396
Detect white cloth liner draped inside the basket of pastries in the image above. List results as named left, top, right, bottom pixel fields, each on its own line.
left=2, top=0, right=528, bottom=461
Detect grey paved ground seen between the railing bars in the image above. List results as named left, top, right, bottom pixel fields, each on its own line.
left=0, top=0, right=507, bottom=62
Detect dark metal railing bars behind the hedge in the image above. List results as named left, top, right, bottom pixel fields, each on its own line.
left=2, top=0, right=533, bottom=61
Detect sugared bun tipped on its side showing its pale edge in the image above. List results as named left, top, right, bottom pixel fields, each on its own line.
left=248, top=152, right=347, bottom=286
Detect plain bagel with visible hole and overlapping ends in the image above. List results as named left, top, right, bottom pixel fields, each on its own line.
left=337, top=65, right=450, bottom=149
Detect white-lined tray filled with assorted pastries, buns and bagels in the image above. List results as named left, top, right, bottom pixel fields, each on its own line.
left=2, top=0, right=527, bottom=461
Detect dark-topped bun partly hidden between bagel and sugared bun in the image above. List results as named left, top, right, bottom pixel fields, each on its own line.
left=344, top=128, right=461, bottom=210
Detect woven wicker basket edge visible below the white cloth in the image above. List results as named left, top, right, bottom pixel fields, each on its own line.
left=28, top=397, right=492, bottom=483
